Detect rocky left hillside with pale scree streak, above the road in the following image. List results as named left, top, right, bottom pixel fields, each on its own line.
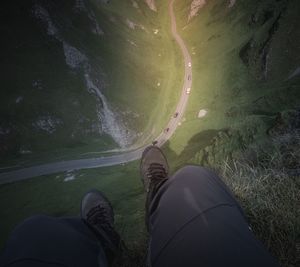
left=0, top=0, right=163, bottom=161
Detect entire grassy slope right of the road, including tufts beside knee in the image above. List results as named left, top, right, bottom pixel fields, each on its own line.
left=164, top=0, right=300, bottom=266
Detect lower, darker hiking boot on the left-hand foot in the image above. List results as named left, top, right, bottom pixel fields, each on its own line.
left=81, top=190, right=121, bottom=260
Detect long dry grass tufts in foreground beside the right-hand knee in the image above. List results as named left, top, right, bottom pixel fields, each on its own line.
left=219, top=161, right=300, bottom=266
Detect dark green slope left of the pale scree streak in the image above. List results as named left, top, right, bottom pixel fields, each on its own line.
left=1, top=2, right=114, bottom=160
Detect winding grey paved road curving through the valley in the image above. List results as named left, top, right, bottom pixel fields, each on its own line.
left=0, top=0, right=192, bottom=184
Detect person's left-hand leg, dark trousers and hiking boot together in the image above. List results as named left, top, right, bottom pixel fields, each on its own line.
left=0, top=190, right=120, bottom=267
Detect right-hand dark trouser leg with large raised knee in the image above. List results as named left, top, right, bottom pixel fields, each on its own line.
left=141, top=147, right=278, bottom=267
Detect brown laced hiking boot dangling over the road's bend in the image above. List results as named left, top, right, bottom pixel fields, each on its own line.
left=140, top=146, right=169, bottom=195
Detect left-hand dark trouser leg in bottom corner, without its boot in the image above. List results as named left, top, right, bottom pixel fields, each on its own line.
left=0, top=215, right=107, bottom=267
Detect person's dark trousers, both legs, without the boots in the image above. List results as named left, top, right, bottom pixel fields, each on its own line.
left=0, top=166, right=278, bottom=267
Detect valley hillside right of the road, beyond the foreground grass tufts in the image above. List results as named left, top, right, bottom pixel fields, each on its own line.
left=172, top=0, right=300, bottom=170
